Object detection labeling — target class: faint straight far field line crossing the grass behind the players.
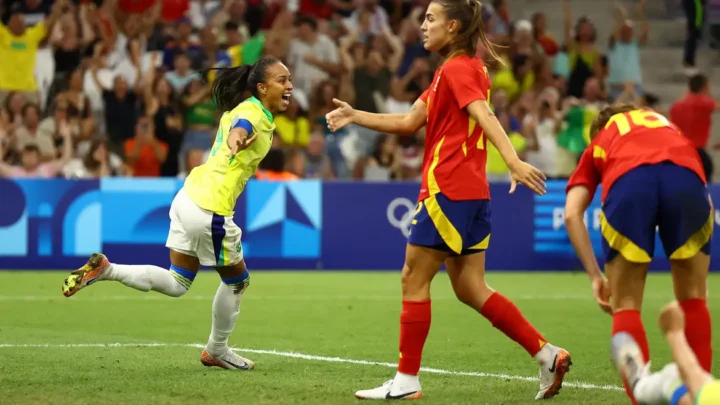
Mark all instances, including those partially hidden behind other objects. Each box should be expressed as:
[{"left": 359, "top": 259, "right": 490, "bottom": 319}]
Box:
[{"left": 0, "top": 292, "right": 688, "bottom": 302}]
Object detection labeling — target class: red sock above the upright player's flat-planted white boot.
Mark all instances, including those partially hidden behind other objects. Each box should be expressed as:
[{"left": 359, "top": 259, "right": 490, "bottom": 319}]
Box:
[{"left": 398, "top": 300, "right": 432, "bottom": 375}]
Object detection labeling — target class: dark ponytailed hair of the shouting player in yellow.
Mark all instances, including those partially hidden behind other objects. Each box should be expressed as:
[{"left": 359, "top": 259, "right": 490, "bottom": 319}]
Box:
[{"left": 201, "top": 56, "right": 280, "bottom": 111}]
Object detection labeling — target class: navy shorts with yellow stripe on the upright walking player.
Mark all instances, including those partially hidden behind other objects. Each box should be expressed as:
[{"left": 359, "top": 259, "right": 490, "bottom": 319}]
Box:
[{"left": 408, "top": 194, "right": 490, "bottom": 255}]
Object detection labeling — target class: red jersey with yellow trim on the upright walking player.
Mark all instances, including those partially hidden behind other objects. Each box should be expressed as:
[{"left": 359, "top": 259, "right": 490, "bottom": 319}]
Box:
[{"left": 418, "top": 56, "right": 490, "bottom": 201}]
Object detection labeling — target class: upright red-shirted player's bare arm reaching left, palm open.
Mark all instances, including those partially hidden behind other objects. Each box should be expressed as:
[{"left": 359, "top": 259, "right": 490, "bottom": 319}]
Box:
[{"left": 325, "top": 99, "right": 427, "bottom": 135}]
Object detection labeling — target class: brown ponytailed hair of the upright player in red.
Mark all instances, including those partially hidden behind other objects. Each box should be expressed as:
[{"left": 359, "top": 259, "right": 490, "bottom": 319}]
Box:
[{"left": 433, "top": 0, "right": 504, "bottom": 64}]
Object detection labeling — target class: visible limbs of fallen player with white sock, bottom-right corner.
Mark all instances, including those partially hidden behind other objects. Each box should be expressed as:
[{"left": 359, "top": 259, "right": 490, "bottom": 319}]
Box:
[{"left": 612, "top": 301, "right": 720, "bottom": 405}]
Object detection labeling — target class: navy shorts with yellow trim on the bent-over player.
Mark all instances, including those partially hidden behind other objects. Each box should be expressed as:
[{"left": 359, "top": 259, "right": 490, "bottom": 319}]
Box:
[{"left": 600, "top": 162, "right": 714, "bottom": 263}]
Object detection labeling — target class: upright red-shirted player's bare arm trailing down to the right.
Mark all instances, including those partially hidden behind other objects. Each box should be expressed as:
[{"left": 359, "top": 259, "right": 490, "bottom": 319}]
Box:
[{"left": 466, "top": 100, "right": 546, "bottom": 195}]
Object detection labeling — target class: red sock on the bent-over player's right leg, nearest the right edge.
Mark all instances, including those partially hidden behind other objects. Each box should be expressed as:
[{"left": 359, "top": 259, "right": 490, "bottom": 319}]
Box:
[{"left": 680, "top": 299, "right": 712, "bottom": 373}]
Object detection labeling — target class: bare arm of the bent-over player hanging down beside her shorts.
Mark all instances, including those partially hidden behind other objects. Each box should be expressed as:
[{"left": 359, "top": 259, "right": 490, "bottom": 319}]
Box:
[{"left": 565, "top": 186, "right": 612, "bottom": 314}]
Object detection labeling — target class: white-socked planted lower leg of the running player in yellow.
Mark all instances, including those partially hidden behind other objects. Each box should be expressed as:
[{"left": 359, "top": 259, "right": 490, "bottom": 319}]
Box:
[{"left": 206, "top": 269, "right": 250, "bottom": 356}]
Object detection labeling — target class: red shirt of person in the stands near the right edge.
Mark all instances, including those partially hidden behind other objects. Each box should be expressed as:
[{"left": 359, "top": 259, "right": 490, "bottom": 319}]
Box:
[{"left": 670, "top": 94, "right": 715, "bottom": 148}]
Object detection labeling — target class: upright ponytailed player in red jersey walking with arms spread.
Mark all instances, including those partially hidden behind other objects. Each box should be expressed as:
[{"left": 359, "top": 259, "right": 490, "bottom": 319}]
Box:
[{"left": 327, "top": 0, "right": 570, "bottom": 399}]
